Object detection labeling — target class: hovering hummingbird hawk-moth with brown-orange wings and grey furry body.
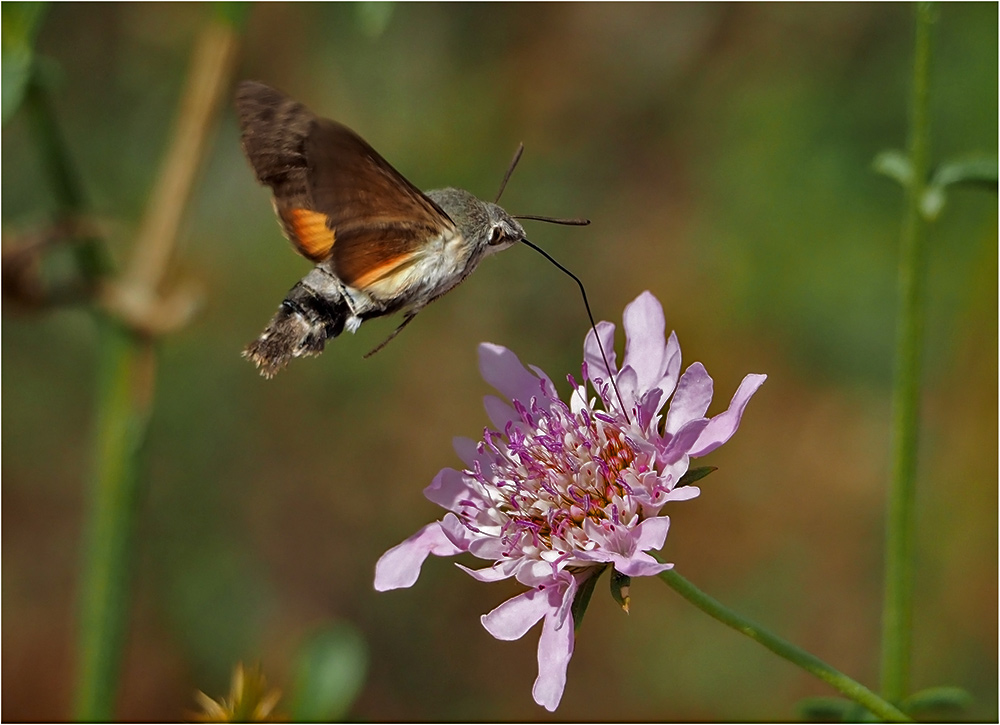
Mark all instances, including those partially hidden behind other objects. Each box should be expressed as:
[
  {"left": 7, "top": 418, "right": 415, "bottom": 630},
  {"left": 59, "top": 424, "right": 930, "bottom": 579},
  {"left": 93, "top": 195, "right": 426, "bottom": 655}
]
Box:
[{"left": 236, "top": 81, "right": 588, "bottom": 378}]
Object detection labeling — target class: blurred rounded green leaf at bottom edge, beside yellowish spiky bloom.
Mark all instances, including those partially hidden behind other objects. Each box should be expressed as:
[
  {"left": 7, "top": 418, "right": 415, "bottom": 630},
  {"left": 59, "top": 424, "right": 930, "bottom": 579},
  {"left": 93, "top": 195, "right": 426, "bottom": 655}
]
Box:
[{"left": 289, "top": 622, "right": 368, "bottom": 722}]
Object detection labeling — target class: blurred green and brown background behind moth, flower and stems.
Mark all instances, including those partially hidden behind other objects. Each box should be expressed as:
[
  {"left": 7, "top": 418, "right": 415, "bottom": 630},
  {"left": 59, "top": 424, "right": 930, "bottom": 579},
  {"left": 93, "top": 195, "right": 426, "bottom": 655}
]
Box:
[{"left": 2, "top": 3, "right": 998, "bottom": 721}]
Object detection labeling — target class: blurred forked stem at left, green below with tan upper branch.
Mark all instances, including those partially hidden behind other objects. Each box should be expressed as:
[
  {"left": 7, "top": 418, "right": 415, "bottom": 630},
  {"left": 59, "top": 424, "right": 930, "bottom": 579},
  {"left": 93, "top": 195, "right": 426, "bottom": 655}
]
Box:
[{"left": 26, "top": 19, "right": 237, "bottom": 722}]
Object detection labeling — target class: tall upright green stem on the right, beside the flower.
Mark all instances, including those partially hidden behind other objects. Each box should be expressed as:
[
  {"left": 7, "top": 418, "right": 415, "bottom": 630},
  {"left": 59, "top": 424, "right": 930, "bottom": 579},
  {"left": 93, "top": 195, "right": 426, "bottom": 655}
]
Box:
[{"left": 881, "top": 2, "right": 934, "bottom": 702}]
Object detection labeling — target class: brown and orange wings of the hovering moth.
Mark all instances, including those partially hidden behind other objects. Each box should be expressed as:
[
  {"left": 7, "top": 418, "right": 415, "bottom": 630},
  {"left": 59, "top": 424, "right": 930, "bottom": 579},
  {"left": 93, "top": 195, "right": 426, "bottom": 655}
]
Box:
[{"left": 236, "top": 81, "right": 458, "bottom": 289}]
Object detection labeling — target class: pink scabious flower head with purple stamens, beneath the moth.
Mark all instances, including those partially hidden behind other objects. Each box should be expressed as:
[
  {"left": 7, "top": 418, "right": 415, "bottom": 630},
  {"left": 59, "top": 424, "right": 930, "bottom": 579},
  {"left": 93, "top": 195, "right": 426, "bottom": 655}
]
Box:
[{"left": 375, "top": 292, "right": 766, "bottom": 711}]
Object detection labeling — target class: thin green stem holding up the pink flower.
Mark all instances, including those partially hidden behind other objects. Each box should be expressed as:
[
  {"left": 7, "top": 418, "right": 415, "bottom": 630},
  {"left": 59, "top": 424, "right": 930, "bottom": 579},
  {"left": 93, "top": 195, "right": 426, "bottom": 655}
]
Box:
[{"left": 658, "top": 569, "right": 910, "bottom": 722}]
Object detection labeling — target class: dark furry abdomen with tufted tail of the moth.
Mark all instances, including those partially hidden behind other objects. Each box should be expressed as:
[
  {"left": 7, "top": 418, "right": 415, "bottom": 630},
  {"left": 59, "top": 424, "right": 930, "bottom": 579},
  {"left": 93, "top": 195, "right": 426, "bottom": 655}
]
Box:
[{"left": 243, "top": 280, "right": 353, "bottom": 378}]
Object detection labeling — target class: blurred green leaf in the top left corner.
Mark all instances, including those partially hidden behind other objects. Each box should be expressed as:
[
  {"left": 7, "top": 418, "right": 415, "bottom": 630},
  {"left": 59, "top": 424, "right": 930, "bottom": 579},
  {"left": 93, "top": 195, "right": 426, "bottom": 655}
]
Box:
[{"left": 0, "top": 2, "right": 45, "bottom": 123}]
